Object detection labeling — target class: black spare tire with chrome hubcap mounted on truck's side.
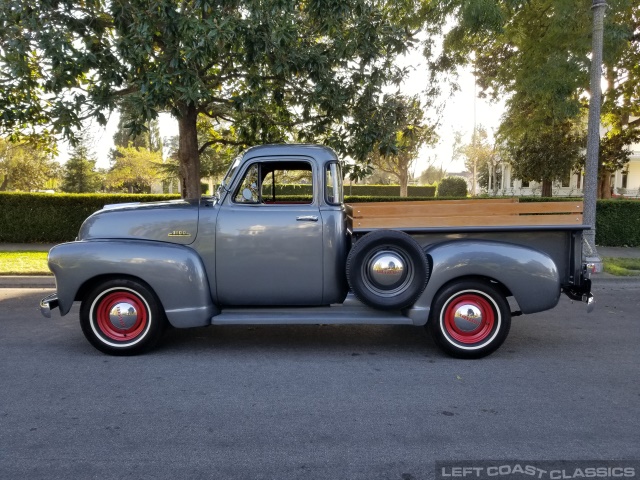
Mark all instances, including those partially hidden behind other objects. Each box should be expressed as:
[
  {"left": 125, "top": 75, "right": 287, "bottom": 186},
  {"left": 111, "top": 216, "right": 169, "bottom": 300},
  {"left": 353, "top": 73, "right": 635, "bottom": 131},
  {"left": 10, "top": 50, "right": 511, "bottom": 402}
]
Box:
[{"left": 347, "top": 230, "right": 429, "bottom": 310}]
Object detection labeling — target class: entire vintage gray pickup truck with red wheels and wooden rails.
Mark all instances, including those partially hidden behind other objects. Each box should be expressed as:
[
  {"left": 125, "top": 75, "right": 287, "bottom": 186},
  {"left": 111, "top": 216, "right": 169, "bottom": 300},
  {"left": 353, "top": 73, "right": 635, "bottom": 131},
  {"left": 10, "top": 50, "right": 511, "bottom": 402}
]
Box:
[{"left": 40, "top": 145, "right": 593, "bottom": 358}]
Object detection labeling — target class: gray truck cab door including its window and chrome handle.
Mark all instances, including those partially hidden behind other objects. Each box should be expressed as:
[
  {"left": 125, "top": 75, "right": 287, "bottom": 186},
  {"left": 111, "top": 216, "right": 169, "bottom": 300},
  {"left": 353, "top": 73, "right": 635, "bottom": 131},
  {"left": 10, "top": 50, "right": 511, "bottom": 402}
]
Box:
[{"left": 216, "top": 158, "right": 323, "bottom": 306}]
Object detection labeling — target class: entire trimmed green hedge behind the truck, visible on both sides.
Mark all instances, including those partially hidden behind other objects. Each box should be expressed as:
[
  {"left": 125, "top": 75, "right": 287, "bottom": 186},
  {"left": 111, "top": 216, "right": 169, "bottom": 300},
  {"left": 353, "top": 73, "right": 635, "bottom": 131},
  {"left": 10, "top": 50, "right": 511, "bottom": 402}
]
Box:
[{"left": 0, "top": 191, "right": 640, "bottom": 247}]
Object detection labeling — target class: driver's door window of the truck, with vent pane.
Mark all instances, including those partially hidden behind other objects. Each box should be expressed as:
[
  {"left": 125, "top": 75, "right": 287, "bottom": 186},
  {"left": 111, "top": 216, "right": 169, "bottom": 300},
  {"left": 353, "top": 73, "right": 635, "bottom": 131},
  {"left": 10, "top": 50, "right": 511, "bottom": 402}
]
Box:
[{"left": 233, "top": 161, "right": 313, "bottom": 205}]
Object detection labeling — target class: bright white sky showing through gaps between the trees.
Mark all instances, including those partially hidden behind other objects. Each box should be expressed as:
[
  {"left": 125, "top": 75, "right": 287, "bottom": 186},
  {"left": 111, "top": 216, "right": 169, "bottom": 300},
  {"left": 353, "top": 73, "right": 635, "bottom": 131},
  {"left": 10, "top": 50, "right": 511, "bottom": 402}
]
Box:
[{"left": 58, "top": 45, "right": 504, "bottom": 175}]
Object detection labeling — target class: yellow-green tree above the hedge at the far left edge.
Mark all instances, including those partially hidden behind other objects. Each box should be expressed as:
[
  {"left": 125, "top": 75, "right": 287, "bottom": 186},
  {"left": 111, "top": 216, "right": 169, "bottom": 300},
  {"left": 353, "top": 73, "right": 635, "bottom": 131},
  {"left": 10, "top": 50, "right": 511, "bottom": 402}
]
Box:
[{"left": 0, "top": 138, "right": 59, "bottom": 192}]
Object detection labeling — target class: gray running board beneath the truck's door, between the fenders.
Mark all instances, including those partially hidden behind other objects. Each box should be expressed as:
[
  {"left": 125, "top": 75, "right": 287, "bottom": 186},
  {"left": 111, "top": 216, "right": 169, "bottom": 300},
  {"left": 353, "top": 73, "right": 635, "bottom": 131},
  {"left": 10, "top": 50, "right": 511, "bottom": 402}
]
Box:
[{"left": 211, "top": 303, "right": 413, "bottom": 325}]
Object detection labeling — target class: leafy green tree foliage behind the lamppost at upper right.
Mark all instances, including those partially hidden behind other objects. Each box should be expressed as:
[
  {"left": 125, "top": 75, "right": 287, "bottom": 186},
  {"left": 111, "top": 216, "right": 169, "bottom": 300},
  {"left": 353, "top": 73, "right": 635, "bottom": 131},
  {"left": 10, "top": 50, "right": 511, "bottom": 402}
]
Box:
[{"left": 428, "top": 0, "right": 640, "bottom": 197}]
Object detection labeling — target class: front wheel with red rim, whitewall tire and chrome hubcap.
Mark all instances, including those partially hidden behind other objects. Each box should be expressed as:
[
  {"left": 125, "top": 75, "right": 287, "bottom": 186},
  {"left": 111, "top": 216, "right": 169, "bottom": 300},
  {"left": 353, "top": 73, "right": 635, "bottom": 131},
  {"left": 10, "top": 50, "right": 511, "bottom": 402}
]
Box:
[{"left": 80, "top": 280, "right": 166, "bottom": 355}]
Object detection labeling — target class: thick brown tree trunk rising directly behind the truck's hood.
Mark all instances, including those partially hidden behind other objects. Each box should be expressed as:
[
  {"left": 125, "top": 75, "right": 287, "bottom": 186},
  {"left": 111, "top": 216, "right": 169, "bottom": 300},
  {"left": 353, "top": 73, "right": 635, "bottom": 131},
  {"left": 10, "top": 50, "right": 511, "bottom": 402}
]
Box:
[{"left": 178, "top": 104, "right": 201, "bottom": 198}]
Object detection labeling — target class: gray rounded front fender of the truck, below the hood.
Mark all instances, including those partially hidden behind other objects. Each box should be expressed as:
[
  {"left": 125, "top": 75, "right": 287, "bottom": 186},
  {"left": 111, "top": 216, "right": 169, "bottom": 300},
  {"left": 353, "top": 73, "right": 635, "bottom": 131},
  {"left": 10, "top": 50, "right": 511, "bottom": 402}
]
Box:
[{"left": 49, "top": 240, "right": 219, "bottom": 328}]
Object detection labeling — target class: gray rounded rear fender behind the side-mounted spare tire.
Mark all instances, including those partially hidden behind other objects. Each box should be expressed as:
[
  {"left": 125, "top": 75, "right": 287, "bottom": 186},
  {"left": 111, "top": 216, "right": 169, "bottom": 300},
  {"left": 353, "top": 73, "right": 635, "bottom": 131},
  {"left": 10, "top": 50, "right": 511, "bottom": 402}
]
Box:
[{"left": 409, "top": 240, "right": 560, "bottom": 323}]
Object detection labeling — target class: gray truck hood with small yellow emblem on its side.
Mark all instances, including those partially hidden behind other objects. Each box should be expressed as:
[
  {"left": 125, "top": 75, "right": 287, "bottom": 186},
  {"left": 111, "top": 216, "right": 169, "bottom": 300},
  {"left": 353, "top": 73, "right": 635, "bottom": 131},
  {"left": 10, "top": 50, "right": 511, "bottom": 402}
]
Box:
[{"left": 78, "top": 200, "right": 199, "bottom": 245}]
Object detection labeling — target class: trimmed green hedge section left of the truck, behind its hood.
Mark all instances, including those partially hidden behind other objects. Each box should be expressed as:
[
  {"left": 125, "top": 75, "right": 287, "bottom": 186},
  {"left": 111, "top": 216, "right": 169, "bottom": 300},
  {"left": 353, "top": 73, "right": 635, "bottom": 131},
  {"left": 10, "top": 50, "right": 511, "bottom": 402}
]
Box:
[{"left": 0, "top": 192, "right": 180, "bottom": 243}]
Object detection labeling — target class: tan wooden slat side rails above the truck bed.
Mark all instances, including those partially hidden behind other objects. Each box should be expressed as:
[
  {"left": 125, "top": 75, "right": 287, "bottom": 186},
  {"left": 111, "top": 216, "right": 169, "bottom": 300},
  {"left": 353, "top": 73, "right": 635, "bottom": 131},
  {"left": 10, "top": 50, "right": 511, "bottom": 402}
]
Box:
[{"left": 345, "top": 198, "right": 583, "bottom": 231}]
